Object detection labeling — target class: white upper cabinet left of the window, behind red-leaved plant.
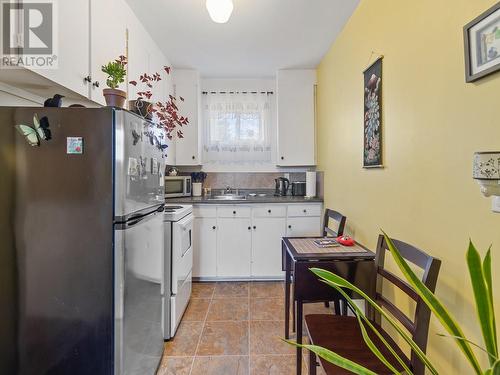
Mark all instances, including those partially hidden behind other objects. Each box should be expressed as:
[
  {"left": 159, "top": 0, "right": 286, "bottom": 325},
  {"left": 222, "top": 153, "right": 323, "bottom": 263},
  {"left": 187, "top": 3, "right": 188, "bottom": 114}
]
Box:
[{"left": 173, "top": 69, "right": 201, "bottom": 165}]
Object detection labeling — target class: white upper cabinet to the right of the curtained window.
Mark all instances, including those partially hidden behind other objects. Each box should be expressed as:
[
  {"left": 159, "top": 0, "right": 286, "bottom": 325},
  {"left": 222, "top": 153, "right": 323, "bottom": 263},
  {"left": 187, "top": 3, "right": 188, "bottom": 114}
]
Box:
[{"left": 277, "top": 70, "right": 316, "bottom": 167}]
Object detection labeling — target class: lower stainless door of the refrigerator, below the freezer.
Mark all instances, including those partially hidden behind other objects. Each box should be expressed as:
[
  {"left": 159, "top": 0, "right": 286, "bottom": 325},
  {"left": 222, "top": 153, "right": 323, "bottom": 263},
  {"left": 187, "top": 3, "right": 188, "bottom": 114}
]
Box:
[{"left": 115, "top": 211, "right": 164, "bottom": 375}]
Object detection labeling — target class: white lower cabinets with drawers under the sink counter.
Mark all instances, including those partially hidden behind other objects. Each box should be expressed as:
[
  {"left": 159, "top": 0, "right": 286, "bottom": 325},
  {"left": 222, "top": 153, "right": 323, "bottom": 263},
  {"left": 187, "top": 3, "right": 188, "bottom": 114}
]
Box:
[{"left": 193, "top": 203, "right": 322, "bottom": 279}]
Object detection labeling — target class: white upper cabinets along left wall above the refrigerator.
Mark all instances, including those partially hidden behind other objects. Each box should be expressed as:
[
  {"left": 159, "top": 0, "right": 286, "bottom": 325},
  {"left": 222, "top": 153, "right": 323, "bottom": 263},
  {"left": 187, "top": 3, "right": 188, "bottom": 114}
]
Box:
[{"left": 4, "top": 0, "right": 168, "bottom": 105}]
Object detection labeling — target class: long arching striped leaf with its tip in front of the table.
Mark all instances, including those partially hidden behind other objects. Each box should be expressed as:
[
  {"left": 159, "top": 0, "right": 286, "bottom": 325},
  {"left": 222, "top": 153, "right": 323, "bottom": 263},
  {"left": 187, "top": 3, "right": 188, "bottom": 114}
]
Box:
[{"left": 310, "top": 268, "right": 438, "bottom": 375}]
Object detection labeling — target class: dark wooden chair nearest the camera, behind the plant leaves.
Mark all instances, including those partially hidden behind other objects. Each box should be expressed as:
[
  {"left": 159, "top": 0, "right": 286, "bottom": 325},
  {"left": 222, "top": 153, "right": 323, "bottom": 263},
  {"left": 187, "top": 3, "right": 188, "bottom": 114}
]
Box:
[{"left": 305, "top": 236, "right": 441, "bottom": 375}]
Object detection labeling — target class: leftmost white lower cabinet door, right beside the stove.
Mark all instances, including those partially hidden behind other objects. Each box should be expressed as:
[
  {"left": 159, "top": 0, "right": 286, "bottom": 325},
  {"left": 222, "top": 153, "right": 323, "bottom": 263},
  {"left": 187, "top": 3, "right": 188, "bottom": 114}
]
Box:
[{"left": 193, "top": 218, "right": 217, "bottom": 277}]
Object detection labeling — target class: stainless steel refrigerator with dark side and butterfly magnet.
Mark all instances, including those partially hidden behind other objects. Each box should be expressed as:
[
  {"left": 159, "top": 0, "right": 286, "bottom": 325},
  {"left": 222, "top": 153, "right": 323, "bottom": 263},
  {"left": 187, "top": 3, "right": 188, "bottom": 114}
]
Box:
[{"left": 0, "top": 107, "right": 165, "bottom": 375}]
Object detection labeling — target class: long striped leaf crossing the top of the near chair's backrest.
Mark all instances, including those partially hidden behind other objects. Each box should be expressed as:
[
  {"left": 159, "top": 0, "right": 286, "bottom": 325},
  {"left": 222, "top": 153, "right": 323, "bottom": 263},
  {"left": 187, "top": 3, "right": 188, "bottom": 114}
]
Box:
[{"left": 383, "top": 232, "right": 483, "bottom": 375}]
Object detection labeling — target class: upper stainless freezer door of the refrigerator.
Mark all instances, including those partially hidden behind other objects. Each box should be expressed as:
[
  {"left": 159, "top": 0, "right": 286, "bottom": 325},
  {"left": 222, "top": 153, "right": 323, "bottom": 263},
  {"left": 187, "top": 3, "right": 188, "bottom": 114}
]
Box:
[{"left": 115, "top": 110, "right": 166, "bottom": 217}]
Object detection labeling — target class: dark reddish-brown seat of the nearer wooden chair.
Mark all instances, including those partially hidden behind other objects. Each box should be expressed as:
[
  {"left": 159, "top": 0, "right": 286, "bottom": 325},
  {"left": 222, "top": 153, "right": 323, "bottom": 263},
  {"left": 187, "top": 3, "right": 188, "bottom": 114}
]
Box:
[{"left": 305, "top": 314, "right": 410, "bottom": 375}]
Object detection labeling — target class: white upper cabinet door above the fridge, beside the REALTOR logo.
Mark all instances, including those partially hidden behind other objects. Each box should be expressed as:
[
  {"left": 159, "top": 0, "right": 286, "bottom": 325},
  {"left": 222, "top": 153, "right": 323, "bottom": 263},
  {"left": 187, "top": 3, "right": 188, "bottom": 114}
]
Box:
[{"left": 33, "top": 0, "right": 90, "bottom": 97}]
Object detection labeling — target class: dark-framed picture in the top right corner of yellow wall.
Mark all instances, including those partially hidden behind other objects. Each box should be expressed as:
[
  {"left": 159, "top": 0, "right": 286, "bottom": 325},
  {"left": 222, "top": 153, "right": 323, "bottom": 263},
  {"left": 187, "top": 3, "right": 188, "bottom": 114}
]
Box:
[{"left": 464, "top": 2, "right": 500, "bottom": 82}]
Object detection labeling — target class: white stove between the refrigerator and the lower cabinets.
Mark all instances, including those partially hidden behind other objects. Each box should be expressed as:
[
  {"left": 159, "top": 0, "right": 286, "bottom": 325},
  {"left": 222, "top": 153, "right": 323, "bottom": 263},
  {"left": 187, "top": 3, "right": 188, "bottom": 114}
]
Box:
[{"left": 163, "top": 204, "right": 193, "bottom": 340}]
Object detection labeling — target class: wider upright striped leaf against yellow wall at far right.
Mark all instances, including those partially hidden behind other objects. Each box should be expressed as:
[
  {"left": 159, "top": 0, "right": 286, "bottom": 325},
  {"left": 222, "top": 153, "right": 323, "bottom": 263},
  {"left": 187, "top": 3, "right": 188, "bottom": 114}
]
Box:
[{"left": 466, "top": 242, "right": 498, "bottom": 366}]
